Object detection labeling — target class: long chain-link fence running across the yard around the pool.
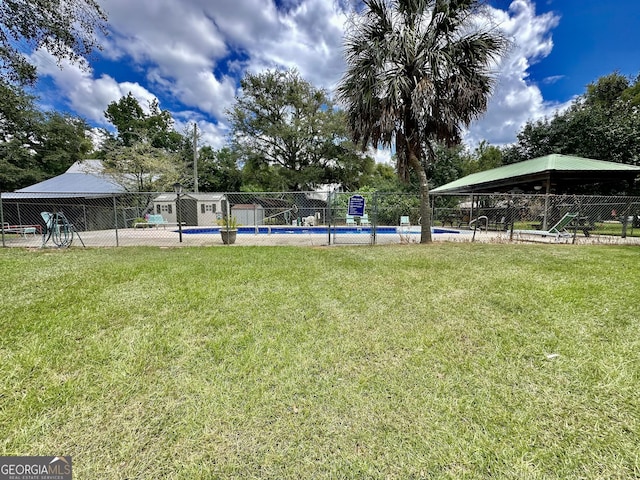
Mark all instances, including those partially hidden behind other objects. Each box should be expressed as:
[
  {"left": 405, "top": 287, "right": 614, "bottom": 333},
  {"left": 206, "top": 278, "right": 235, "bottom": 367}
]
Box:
[{"left": 0, "top": 192, "right": 640, "bottom": 247}]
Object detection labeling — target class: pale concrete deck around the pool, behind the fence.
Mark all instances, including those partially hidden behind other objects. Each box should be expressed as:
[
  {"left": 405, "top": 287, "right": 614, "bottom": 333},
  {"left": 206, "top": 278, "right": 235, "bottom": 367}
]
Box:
[{"left": 5, "top": 227, "right": 640, "bottom": 248}]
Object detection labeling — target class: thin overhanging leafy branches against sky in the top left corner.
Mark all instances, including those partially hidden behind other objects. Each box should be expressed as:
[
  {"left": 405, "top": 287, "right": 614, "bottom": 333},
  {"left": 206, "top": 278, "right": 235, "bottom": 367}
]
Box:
[{"left": 0, "top": 0, "right": 107, "bottom": 84}]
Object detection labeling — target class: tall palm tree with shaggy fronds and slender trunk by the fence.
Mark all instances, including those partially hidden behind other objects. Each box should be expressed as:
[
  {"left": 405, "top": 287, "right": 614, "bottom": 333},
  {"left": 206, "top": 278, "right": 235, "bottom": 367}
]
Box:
[{"left": 337, "top": 0, "right": 507, "bottom": 243}]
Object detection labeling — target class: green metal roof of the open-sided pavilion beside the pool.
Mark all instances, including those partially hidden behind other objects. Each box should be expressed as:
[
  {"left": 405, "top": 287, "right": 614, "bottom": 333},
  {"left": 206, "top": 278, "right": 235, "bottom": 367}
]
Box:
[{"left": 431, "top": 154, "right": 640, "bottom": 193}]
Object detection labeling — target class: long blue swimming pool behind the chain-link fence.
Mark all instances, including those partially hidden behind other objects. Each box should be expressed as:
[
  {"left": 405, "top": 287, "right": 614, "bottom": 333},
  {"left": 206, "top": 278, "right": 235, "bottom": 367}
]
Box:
[{"left": 176, "top": 225, "right": 460, "bottom": 235}]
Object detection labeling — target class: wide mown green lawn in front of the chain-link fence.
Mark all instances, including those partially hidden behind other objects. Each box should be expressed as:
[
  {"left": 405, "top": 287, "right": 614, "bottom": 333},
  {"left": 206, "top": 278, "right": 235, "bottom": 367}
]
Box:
[{"left": 0, "top": 243, "right": 640, "bottom": 479}]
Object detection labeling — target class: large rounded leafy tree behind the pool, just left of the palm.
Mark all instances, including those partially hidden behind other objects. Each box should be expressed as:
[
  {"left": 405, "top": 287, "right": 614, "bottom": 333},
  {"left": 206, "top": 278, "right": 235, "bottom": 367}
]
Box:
[{"left": 228, "top": 70, "right": 372, "bottom": 191}]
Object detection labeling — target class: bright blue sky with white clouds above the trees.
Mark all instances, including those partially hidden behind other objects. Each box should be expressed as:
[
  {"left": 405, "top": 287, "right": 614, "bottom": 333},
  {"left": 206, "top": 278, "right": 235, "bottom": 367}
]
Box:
[{"left": 27, "top": 0, "right": 640, "bottom": 161}]
